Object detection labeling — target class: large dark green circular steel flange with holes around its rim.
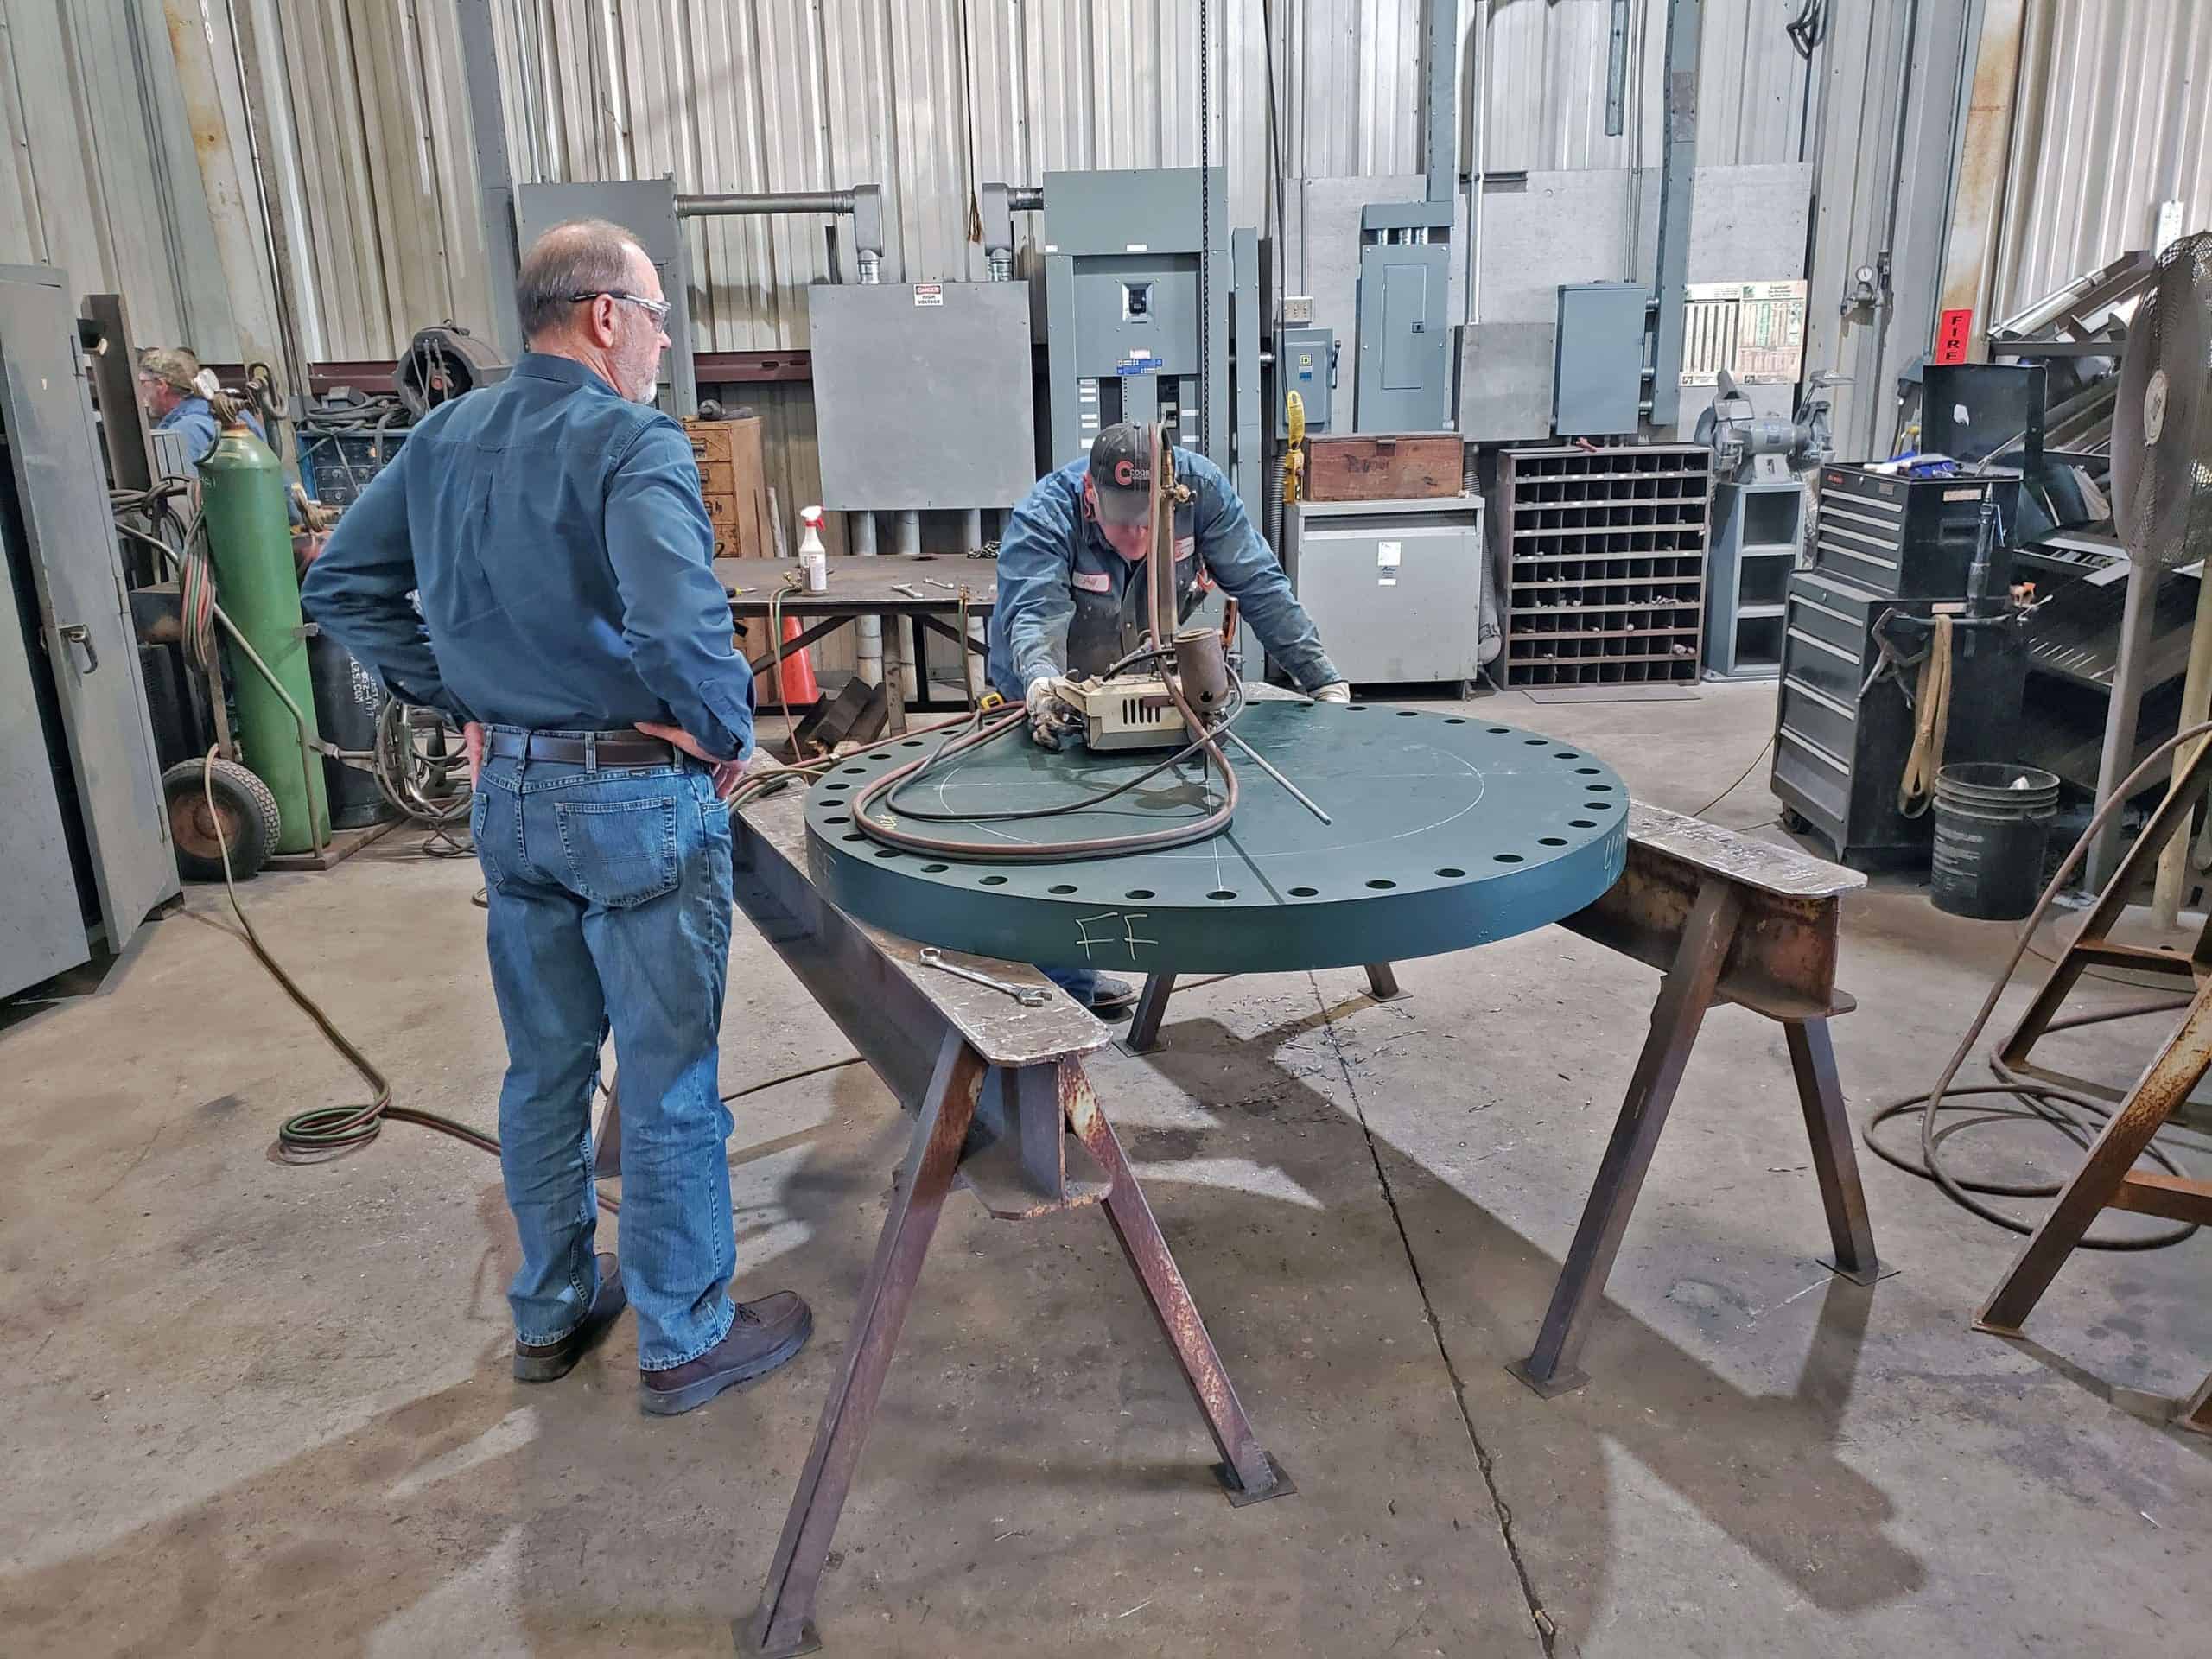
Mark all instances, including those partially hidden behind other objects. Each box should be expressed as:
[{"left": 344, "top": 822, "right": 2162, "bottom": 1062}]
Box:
[{"left": 807, "top": 702, "right": 1628, "bottom": 973}]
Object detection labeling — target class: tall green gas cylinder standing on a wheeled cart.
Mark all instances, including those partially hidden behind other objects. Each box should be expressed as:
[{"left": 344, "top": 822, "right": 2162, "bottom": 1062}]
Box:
[{"left": 199, "top": 423, "right": 329, "bottom": 852}]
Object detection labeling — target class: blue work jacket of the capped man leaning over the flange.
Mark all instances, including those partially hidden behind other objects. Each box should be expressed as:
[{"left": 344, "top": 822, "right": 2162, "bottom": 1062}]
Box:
[{"left": 991, "top": 449, "right": 1343, "bottom": 702}]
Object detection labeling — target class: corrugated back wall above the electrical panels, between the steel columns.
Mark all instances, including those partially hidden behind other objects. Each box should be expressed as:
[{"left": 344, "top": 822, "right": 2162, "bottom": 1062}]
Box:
[{"left": 462, "top": 0, "right": 1805, "bottom": 349}]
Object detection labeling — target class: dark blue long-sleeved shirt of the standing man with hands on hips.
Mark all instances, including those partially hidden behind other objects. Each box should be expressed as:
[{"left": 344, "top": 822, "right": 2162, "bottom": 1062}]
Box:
[{"left": 299, "top": 352, "right": 752, "bottom": 759}]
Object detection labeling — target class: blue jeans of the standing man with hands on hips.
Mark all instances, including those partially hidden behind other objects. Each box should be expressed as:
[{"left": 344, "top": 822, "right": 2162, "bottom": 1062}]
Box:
[{"left": 471, "top": 728, "right": 736, "bottom": 1371}]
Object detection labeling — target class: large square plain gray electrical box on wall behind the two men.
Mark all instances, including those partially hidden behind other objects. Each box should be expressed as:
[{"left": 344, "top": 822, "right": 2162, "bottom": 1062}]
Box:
[{"left": 807, "top": 283, "right": 1038, "bottom": 513}]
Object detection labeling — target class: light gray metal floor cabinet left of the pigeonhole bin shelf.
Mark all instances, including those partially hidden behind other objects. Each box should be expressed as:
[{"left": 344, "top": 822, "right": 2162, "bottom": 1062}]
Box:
[{"left": 1283, "top": 495, "right": 1486, "bottom": 686}]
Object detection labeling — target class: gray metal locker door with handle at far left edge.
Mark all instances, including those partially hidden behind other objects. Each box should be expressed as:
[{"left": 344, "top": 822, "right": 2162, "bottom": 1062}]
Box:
[{"left": 0, "top": 265, "right": 177, "bottom": 951}]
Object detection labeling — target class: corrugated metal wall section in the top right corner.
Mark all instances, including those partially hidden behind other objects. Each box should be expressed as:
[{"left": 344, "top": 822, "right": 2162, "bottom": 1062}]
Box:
[{"left": 1993, "top": 0, "right": 2212, "bottom": 316}]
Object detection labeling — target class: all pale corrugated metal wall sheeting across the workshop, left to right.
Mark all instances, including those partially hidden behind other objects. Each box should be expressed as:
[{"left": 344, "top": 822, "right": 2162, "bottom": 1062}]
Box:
[{"left": 0, "top": 0, "right": 2212, "bottom": 448}]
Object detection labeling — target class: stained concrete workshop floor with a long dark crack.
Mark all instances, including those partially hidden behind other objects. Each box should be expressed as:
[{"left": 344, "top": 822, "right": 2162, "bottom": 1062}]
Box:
[{"left": 0, "top": 686, "right": 2212, "bottom": 1659}]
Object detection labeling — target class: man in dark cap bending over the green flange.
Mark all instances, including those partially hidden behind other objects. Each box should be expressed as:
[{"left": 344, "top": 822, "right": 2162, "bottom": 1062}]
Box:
[{"left": 991, "top": 423, "right": 1351, "bottom": 1013}]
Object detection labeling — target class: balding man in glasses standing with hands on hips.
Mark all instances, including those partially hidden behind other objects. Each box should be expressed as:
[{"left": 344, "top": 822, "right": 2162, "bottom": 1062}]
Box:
[{"left": 301, "top": 221, "right": 812, "bottom": 1415}]
